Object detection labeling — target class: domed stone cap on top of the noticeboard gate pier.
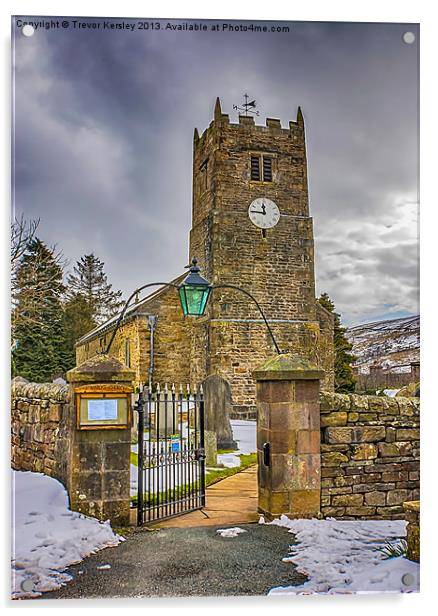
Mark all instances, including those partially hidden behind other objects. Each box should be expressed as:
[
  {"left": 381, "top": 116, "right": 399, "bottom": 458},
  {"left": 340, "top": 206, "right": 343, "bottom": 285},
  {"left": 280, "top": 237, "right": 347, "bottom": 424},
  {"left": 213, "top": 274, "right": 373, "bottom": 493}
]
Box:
[{"left": 67, "top": 354, "right": 135, "bottom": 383}]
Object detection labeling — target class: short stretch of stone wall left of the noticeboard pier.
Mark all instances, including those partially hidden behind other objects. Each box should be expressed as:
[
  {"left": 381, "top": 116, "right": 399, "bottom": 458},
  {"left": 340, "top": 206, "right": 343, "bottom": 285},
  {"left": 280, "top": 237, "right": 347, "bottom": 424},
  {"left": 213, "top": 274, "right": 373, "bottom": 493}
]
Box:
[{"left": 11, "top": 378, "right": 69, "bottom": 484}]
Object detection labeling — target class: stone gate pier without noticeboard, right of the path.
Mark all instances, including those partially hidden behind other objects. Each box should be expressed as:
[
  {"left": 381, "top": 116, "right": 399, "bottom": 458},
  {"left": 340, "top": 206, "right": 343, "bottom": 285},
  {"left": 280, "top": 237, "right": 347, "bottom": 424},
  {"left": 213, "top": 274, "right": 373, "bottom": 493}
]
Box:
[{"left": 253, "top": 354, "right": 324, "bottom": 517}]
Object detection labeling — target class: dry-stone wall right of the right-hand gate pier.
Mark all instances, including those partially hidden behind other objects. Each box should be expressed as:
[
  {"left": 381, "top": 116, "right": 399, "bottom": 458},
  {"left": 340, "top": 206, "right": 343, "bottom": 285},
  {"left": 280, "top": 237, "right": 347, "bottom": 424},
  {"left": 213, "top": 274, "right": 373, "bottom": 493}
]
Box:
[{"left": 320, "top": 392, "right": 420, "bottom": 519}]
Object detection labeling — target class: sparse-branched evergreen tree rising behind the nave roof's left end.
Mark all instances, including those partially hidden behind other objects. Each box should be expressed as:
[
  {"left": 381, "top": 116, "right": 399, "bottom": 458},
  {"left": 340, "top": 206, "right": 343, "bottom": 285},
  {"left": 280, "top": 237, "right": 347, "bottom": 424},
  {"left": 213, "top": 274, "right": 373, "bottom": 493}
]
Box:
[{"left": 67, "top": 253, "right": 123, "bottom": 324}]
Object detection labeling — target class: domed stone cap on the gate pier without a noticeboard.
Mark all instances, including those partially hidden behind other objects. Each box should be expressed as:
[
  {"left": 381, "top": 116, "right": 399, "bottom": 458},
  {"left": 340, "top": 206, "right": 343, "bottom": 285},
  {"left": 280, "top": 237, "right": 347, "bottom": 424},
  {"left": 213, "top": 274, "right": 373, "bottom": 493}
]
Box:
[{"left": 252, "top": 353, "right": 324, "bottom": 381}]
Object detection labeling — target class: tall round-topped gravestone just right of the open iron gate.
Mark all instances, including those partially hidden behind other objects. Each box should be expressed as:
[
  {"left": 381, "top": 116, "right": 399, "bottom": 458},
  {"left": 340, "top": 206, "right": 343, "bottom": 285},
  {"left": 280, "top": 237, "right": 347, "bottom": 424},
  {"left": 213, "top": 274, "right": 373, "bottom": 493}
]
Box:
[{"left": 202, "top": 375, "right": 237, "bottom": 449}]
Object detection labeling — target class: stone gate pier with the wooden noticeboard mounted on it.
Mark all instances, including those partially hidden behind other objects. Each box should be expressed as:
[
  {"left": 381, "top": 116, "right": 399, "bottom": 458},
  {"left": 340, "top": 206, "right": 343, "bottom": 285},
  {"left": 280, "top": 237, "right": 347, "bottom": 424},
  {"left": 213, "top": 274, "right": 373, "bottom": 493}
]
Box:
[{"left": 67, "top": 355, "right": 135, "bottom": 526}]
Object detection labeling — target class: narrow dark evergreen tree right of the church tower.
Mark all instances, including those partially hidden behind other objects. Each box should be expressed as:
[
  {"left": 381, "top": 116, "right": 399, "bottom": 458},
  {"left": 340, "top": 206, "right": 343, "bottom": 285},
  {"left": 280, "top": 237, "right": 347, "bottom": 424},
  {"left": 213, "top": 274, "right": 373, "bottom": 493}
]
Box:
[{"left": 318, "top": 293, "right": 356, "bottom": 393}]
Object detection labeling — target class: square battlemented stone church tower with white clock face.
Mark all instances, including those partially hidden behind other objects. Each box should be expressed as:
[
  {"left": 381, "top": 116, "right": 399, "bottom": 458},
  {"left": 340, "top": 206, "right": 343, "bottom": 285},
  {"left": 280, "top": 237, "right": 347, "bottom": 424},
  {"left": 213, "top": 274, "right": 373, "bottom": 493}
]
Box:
[{"left": 190, "top": 99, "right": 333, "bottom": 412}]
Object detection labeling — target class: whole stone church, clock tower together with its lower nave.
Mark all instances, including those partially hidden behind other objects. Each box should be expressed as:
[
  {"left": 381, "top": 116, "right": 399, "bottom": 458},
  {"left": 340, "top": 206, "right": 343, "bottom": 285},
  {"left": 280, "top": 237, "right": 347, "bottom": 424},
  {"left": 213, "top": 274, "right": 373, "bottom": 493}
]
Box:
[{"left": 76, "top": 98, "right": 334, "bottom": 418}]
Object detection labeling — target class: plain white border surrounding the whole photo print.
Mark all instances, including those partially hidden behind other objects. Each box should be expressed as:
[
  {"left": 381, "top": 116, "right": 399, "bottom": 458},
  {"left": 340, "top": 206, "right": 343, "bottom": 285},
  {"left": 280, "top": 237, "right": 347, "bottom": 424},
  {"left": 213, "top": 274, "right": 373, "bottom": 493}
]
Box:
[{"left": 0, "top": 0, "right": 438, "bottom": 616}]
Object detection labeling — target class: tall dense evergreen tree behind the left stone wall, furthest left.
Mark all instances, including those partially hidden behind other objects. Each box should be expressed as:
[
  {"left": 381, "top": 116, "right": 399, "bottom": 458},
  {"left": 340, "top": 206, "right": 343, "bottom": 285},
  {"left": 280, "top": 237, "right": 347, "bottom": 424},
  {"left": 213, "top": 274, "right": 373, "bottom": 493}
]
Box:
[{"left": 12, "top": 238, "right": 72, "bottom": 382}]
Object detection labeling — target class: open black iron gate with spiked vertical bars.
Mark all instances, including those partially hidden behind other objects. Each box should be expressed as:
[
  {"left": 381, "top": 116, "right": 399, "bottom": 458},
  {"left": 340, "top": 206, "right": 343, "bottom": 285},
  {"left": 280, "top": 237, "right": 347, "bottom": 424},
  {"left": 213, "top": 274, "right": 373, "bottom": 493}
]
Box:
[{"left": 135, "top": 385, "right": 205, "bottom": 526}]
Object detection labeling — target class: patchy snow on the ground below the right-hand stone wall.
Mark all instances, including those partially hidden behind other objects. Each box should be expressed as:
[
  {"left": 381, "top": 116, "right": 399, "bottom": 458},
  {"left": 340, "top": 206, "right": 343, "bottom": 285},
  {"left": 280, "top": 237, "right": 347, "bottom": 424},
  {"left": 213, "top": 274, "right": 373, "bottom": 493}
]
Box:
[{"left": 260, "top": 515, "right": 420, "bottom": 595}]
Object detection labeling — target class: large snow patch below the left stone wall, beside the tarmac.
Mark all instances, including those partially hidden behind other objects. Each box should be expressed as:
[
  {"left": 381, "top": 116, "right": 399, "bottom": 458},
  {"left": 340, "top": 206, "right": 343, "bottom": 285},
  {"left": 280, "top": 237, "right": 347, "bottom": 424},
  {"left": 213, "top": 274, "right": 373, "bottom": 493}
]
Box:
[{"left": 12, "top": 471, "right": 124, "bottom": 598}]
